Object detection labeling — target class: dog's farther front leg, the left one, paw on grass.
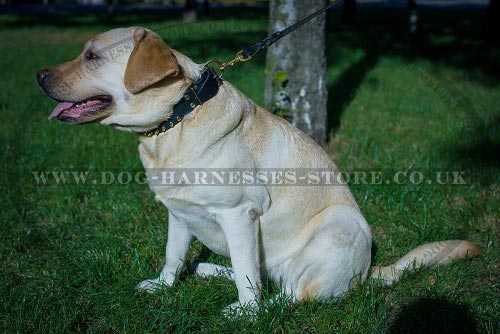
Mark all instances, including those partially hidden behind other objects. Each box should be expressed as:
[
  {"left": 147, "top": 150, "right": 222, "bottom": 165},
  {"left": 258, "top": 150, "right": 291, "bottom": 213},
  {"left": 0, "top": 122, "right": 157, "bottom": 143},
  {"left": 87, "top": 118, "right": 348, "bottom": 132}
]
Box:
[{"left": 137, "top": 212, "right": 193, "bottom": 292}]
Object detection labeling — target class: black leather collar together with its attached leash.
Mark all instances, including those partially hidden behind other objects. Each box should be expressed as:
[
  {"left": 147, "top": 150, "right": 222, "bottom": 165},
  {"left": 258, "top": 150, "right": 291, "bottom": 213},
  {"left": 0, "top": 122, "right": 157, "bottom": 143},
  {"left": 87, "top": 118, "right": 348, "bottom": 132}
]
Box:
[{"left": 139, "top": 0, "right": 338, "bottom": 137}]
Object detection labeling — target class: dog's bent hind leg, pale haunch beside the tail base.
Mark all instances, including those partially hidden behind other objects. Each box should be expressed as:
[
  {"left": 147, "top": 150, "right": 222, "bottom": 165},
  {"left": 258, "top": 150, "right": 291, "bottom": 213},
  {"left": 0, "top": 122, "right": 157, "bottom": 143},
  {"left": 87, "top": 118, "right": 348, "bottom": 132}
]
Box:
[{"left": 286, "top": 205, "right": 371, "bottom": 301}]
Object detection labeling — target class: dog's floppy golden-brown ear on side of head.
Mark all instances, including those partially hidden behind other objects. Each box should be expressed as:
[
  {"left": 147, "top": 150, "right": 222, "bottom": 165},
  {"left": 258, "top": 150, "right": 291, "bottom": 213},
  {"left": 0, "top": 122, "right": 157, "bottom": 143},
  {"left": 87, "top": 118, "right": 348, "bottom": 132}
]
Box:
[{"left": 124, "top": 28, "right": 179, "bottom": 94}]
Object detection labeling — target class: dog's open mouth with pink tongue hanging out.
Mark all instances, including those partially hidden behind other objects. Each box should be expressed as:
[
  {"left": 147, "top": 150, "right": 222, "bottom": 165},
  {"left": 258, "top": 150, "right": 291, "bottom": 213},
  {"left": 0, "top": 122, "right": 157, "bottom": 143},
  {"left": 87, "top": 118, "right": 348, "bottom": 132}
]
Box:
[{"left": 49, "top": 95, "right": 113, "bottom": 121}]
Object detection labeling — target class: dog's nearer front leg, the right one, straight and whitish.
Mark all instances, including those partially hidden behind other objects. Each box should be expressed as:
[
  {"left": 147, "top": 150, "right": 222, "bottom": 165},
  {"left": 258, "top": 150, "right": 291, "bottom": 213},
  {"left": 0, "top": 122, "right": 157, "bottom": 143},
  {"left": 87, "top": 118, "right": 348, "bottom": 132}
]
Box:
[{"left": 220, "top": 208, "right": 261, "bottom": 314}]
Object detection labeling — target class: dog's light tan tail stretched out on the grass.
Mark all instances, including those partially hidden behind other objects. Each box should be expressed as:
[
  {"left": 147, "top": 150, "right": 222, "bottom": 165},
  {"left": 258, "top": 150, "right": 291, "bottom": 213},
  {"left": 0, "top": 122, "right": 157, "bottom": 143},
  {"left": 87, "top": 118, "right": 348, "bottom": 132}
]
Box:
[{"left": 371, "top": 240, "right": 481, "bottom": 285}]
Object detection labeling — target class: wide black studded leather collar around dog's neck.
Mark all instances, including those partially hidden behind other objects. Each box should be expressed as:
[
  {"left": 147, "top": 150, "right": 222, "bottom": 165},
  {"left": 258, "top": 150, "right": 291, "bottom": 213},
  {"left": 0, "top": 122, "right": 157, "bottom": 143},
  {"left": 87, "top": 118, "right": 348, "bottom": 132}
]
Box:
[{"left": 139, "top": 67, "right": 222, "bottom": 137}]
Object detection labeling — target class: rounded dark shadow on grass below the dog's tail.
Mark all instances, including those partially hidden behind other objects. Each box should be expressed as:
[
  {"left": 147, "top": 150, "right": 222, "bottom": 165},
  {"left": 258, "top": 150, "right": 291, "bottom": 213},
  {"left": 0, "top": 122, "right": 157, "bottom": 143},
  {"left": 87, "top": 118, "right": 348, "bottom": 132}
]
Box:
[{"left": 390, "top": 298, "right": 478, "bottom": 334}]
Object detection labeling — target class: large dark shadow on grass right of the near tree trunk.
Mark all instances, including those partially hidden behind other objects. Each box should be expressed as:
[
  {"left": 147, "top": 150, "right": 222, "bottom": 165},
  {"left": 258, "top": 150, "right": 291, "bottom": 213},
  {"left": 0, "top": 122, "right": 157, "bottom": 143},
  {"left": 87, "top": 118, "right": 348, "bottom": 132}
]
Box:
[{"left": 327, "top": 9, "right": 500, "bottom": 139}]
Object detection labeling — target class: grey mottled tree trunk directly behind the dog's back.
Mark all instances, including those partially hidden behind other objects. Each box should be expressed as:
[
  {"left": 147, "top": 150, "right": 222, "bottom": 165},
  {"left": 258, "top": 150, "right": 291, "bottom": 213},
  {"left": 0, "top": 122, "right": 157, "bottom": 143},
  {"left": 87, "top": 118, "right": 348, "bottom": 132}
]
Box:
[{"left": 265, "top": 0, "right": 328, "bottom": 144}]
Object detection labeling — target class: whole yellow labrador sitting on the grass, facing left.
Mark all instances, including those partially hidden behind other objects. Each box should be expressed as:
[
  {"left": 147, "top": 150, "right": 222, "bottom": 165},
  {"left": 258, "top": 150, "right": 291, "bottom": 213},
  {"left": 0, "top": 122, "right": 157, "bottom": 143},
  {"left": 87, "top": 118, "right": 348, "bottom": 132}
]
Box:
[{"left": 37, "top": 27, "right": 479, "bottom": 309}]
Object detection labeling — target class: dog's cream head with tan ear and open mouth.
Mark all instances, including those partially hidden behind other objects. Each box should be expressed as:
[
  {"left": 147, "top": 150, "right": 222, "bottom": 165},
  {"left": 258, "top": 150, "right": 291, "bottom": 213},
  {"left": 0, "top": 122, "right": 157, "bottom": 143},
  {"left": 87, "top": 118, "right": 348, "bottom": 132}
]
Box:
[{"left": 37, "top": 27, "right": 199, "bottom": 131}]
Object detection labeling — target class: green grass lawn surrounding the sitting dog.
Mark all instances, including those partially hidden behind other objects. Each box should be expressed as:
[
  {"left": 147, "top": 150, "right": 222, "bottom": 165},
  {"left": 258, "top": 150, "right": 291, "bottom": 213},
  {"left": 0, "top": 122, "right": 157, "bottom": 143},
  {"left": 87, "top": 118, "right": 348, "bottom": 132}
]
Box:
[{"left": 0, "top": 7, "right": 500, "bottom": 333}]
